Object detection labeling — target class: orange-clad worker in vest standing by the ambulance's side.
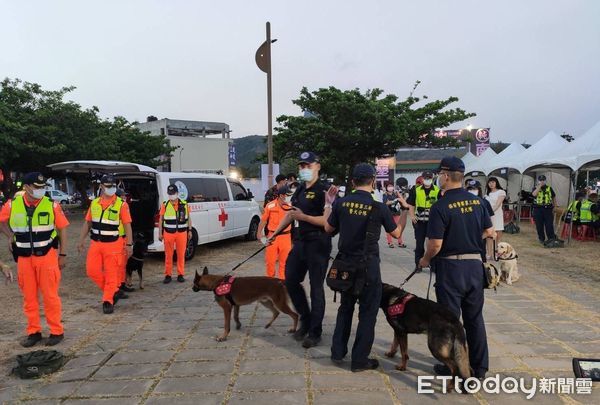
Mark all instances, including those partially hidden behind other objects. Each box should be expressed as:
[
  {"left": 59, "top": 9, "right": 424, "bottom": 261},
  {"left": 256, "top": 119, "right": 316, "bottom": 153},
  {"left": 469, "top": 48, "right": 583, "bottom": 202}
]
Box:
[{"left": 158, "top": 184, "right": 192, "bottom": 284}]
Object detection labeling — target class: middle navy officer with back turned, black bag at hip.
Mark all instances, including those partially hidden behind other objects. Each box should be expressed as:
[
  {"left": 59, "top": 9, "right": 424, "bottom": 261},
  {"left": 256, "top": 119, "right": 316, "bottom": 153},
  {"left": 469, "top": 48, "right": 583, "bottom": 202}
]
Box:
[{"left": 325, "top": 163, "right": 401, "bottom": 372}]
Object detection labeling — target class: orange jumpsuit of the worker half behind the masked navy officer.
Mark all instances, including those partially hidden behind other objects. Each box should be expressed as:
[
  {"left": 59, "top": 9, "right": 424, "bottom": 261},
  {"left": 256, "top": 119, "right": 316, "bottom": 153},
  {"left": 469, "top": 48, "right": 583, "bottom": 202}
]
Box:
[{"left": 261, "top": 200, "right": 292, "bottom": 280}]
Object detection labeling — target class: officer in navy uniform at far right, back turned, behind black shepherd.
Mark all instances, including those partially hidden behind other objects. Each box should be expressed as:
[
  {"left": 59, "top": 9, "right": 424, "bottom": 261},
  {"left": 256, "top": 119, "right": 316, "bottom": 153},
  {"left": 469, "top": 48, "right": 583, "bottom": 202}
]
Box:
[{"left": 419, "top": 157, "right": 494, "bottom": 378}]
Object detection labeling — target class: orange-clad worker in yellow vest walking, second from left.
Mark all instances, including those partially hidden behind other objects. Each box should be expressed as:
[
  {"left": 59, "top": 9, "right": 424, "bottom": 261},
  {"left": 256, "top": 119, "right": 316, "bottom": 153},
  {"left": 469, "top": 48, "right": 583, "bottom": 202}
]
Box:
[{"left": 77, "top": 174, "right": 133, "bottom": 314}]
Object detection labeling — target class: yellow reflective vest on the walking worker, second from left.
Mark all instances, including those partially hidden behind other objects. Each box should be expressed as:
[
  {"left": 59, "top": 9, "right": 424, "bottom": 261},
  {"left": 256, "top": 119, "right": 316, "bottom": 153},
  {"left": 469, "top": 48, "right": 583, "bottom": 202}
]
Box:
[{"left": 90, "top": 197, "right": 125, "bottom": 242}]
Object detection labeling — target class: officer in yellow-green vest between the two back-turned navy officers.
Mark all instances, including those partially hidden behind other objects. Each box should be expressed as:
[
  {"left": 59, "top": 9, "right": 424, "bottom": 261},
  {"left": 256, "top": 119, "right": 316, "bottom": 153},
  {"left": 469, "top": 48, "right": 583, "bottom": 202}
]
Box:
[{"left": 406, "top": 170, "right": 440, "bottom": 269}]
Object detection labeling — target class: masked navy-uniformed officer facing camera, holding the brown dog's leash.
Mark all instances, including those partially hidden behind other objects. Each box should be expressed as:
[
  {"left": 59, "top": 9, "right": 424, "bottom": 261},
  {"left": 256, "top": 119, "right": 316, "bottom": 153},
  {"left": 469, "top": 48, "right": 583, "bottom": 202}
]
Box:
[{"left": 269, "top": 152, "right": 337, "bottom": 348}]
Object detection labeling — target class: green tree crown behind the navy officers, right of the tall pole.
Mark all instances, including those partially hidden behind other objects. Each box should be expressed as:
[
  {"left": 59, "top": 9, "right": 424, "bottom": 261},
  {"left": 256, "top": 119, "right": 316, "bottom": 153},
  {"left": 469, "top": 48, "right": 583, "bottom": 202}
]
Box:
[{"left": 273, "top": 82, "right": 475, "bottom": 180}]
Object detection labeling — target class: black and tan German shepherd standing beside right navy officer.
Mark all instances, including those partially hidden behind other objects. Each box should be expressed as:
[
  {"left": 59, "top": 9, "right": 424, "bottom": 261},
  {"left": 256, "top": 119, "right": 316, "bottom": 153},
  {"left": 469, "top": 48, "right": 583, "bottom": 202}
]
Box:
[{"left": 380, "top": 283, "right": 471, "bottom": 386}]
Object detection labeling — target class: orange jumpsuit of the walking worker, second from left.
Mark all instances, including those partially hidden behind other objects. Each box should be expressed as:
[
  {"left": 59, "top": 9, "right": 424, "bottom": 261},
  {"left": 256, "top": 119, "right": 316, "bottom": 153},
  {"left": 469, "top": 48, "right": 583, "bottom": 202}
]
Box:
[{"left": 85, "top": 195, "right": 131, "bottom": 304}]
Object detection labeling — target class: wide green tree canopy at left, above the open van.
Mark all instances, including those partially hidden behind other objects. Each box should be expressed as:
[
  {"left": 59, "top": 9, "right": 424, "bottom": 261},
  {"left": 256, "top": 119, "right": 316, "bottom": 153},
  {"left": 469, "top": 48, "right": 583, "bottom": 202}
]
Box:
[{"left": 0, "top": 79, "right": 174, "bottom": 178}]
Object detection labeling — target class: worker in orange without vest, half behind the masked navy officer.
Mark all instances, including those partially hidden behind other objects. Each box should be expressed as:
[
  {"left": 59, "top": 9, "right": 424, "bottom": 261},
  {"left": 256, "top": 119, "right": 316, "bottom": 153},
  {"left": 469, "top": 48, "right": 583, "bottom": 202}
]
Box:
[{"left": 258, "top": 186, "right": 293, "bottom": 280}]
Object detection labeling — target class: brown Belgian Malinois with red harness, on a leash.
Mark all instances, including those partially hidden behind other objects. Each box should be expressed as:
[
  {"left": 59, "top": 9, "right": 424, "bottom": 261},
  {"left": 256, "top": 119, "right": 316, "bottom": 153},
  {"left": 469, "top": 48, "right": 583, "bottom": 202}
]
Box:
[{"left": 192, "top": 267, "right": 298, "bottom": 342}]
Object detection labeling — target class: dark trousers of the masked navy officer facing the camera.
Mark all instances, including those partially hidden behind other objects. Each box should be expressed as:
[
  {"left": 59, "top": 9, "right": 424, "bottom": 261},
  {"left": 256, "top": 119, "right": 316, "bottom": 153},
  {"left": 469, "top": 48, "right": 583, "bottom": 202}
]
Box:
[{"left": 285, "top": 235, "right": 331, "bottom": 337}]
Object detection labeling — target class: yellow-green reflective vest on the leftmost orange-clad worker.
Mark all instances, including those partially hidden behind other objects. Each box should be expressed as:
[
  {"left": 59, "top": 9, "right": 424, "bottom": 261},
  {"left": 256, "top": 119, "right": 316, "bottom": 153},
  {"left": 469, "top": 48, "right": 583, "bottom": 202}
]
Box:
[{"left": 9, "top": 196, "right": 57, "bottom": 257}]
